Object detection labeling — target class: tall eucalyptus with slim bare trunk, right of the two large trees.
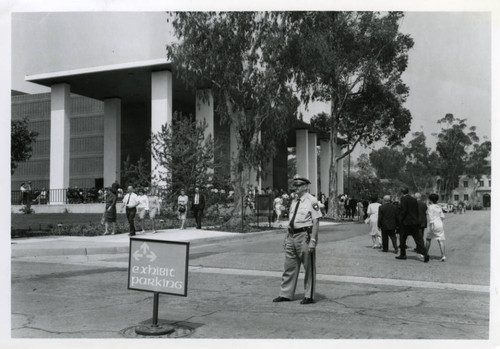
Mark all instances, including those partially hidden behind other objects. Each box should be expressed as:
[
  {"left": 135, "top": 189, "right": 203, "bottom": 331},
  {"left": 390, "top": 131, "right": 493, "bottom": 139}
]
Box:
[{"left": 280, "top": 12, "right": 413, "bottom": 217}]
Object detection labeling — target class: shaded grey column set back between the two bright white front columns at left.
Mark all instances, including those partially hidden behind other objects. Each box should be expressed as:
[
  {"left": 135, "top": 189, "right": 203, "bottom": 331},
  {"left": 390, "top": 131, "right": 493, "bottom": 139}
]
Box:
[{"left": 103, "top": 98, "right": 122, "bottom": 187}]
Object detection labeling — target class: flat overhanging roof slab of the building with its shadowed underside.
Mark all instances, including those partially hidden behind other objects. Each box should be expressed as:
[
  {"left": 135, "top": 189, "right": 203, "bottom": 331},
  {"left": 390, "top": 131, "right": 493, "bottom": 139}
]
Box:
[{"left": 25, "top": 58, "right": 195, "bottom": 104}]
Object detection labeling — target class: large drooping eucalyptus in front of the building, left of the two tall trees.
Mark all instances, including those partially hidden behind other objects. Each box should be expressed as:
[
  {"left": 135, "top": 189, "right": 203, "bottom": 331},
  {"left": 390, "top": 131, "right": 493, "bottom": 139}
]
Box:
[{"left": 167, "top": 12, "right": 299, "bottom": 226}]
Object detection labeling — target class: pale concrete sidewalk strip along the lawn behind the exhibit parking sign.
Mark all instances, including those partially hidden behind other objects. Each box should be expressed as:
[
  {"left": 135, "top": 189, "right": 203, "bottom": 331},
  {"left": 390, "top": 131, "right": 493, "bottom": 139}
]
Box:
[{"left": 11, "top": 221, "right": 338, "bottom": 258}]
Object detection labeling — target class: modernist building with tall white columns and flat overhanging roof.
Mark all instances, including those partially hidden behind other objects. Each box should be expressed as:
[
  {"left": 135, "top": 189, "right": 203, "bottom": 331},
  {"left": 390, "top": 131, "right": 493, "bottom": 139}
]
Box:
[{"left": 12, "top": 59, "right": 343, "bottom": 204}]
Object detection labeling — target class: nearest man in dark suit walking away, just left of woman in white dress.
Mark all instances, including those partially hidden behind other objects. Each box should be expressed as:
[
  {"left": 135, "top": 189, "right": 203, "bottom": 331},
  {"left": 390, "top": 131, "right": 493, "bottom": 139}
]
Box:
[{"left": 396, "top": 188, "right": 429, "bottom": 263}]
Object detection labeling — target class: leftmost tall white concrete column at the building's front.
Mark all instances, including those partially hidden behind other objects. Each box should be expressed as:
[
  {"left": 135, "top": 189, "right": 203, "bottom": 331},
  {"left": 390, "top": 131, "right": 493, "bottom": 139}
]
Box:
[{"left": 50, "top": 83, "right": 71, "bottom": 205}]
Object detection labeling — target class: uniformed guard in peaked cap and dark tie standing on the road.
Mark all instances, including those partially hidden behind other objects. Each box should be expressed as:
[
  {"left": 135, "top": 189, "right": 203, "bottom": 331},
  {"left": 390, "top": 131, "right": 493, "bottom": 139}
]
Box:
[{"left": 273, "top": 175, "right": 322, "bottom": 304}]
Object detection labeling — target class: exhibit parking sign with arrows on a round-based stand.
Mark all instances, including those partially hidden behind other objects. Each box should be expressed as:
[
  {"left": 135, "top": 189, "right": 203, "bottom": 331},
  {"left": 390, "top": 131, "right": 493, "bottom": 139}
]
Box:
[{"left": 128, "top": 238, "right": 189, "bottom": 336}]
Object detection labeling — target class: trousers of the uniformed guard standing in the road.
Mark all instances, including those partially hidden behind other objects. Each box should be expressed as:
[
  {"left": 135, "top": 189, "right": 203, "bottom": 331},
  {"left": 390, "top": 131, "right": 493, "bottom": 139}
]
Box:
[{"left": 280, "top": 232, "right": 316, "bottom": 299}]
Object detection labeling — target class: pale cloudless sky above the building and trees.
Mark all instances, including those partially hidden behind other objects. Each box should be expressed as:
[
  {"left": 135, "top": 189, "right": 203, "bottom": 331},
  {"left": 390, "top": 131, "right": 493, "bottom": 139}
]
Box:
[{"left": 12, "top": 11, "right": 492, "bottom": 158}]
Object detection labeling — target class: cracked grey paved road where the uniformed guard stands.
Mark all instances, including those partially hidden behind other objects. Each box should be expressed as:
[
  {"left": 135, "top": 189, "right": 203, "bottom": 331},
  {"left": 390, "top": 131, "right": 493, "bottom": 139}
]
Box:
[{"left": 12, "top": 211, "right": 490, "bottom": 339}]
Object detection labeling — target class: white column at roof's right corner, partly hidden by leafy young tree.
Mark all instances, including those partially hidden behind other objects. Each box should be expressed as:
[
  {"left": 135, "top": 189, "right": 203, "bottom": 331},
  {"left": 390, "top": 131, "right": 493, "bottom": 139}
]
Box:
[{"left": 151, "top": 70, "right": 173, "bottom": 186}]
